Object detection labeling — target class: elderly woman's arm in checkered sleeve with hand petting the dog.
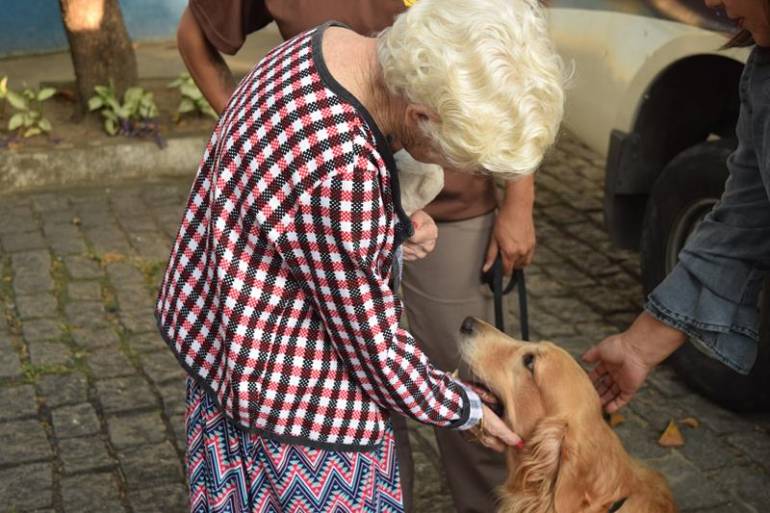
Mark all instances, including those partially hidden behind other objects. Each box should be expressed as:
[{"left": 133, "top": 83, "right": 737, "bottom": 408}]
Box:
[{"left": 276, "top": 150, "right": 519, "bottom": 445}]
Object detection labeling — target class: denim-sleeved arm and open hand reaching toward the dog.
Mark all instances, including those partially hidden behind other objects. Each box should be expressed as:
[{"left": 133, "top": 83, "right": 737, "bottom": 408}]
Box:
[{"left": 584, "top": 114, "right": 770, "bottom": 411}]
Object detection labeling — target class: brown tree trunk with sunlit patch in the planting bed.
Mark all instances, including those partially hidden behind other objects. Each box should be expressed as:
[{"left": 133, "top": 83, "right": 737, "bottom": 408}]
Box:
[{"left": 59, "top": 0, "right": 137, "bottom": 114}]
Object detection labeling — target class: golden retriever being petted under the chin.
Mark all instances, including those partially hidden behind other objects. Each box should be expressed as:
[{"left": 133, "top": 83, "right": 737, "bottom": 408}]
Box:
[{"left": 460, "top": 317, "right": 677, "bottom": 513}]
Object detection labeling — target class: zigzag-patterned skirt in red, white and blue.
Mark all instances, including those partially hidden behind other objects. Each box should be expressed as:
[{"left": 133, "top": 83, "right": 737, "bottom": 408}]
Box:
[{"left": 185, "top": 378, "right": 404, "bottom": 513}]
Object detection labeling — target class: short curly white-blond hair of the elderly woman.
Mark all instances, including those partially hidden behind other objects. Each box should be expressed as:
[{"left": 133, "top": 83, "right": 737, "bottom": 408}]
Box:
[{"left": 377, "top": 0, "right": 565, "bottom": 175}]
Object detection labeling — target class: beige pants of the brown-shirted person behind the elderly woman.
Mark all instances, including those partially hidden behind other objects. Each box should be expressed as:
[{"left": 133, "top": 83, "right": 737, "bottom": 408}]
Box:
[{"left": 393, "top": 213, "right": 506, "bottom": 513}]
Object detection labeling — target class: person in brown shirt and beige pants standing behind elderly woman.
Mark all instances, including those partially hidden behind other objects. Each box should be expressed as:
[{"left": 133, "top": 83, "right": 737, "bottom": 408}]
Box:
[{"left": 177, "top": 0, "right": 535, "bottom": 513}]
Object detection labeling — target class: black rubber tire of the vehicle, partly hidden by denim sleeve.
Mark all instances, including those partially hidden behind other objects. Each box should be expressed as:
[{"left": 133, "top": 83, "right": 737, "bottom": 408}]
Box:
[{"left": 641, "top": 140, "right": 770, "bottom": 412}]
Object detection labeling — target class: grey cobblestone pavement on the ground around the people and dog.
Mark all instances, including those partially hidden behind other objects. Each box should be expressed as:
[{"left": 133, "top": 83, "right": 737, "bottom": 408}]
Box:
[{"left": 0, "top": 135, "right": 770, "bottom": 513}]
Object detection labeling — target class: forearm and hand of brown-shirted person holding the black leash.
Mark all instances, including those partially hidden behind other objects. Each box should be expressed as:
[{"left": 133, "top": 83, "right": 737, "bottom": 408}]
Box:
[{"left": 482, "top": 175, "right": 535, "bottom": 274}]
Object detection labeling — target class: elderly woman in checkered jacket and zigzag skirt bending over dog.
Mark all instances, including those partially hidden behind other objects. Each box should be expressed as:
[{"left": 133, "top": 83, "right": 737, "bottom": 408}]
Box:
[{"left": 157, "top": 0, "right": 563, "bottom": 512}]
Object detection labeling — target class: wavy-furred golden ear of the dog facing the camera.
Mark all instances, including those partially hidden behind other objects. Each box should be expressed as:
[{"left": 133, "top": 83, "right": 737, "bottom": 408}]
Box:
[{"left": 514, "top": 417, "right": 586, "bottom": 513}]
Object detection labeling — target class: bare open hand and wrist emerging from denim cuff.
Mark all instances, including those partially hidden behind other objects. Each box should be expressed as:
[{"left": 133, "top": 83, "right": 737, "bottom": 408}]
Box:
[{"left": 583, "top": 312, "right": 687, "bottom": 413}]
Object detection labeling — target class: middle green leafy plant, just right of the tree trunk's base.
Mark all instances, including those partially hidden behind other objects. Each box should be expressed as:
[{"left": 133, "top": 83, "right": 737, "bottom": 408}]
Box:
[{"left": 88, "top": 82, "right": 164, "bottom": 147}]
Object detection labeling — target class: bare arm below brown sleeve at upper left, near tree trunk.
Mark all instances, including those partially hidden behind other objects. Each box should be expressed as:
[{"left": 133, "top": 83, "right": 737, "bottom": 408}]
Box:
[{"left": 176, "top": 7, "right": 235, "bottom": 115}]
